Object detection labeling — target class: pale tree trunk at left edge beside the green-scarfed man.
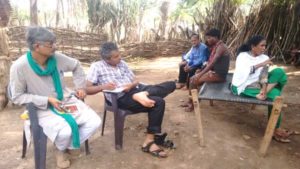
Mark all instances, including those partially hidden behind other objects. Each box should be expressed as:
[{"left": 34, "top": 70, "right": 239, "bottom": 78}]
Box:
[{"left": 0, "top": 28, "right": 11, "bottom": 111}]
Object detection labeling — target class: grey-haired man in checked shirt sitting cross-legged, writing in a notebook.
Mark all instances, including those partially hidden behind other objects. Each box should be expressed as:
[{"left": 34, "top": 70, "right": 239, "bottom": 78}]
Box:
[{"left": 87, "top": 42, "right": 176, "bottom": 157}]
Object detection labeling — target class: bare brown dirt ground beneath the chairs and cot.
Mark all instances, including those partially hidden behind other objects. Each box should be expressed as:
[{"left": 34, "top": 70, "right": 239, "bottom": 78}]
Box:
[{"left": 0, "top": 57, "right": 300, "bottom": 169}]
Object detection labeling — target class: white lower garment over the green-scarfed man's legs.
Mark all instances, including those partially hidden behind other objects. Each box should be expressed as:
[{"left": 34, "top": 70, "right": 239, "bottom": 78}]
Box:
[{"left": 24, "top": 97, "right": 101, "bottom": 150}]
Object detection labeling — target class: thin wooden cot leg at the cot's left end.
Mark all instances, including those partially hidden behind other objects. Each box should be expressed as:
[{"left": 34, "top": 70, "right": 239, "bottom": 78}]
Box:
[{"left": 192, "top": 89, "right": 204, "bottom": 147}]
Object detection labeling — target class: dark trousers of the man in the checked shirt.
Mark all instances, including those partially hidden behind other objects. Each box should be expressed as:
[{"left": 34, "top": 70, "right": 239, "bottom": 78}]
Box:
[{"left": 118, "top": 81, "right": 176, "bottom": 134}]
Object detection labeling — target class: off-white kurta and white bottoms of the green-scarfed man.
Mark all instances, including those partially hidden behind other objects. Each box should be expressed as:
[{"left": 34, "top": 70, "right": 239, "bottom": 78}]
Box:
[{"left": 9, "top": 53, "right": 101, "bottom": 150}]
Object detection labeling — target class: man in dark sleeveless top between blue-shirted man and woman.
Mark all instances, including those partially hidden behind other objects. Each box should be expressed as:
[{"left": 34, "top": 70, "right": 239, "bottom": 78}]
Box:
[{"left": 186, "top": 28, "right": 230, "bottom": 111}]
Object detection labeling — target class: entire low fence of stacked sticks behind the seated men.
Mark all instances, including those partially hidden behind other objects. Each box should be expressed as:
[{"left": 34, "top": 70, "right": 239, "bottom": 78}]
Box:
[{"left": 8, "top": 27, "right": 191, "bottom": 62}]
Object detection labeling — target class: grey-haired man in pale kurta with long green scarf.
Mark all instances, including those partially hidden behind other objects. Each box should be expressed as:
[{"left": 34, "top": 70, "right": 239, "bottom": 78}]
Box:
[{"left": 9, "top": 27, "right": 101, "bottom": 168}]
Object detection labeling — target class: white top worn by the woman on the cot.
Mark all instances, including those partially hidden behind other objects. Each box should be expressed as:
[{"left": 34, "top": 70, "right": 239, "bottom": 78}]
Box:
[{"left": 232, "top": 52, "right": 269, "bottom": 94}]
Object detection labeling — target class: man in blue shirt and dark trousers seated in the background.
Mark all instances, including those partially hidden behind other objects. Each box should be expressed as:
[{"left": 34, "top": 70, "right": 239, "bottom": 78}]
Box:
[{"left": 176, "top": 34, "right": 209, "bottom": 89}]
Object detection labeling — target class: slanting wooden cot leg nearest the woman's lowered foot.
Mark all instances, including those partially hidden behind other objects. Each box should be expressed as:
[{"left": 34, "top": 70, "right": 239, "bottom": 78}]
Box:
[{"left": 259, "top": 96, "right": 283, "bottom": 156}]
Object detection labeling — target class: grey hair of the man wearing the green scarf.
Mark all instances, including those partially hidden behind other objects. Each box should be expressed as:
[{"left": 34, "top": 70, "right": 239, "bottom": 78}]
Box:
[{"left": 26, "top": 26, "right": 56, "bottom": 50}]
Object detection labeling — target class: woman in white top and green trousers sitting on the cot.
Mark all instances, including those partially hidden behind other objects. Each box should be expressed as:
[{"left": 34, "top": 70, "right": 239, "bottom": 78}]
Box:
[{"left": 231, "top": 36, "right": 294, "bottom": 142}]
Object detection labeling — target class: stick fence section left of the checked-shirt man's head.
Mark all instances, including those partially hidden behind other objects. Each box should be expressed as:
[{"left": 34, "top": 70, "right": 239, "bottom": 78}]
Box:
[{"left": 8, "top": 26, "right": 108, "bottom": 61}]
